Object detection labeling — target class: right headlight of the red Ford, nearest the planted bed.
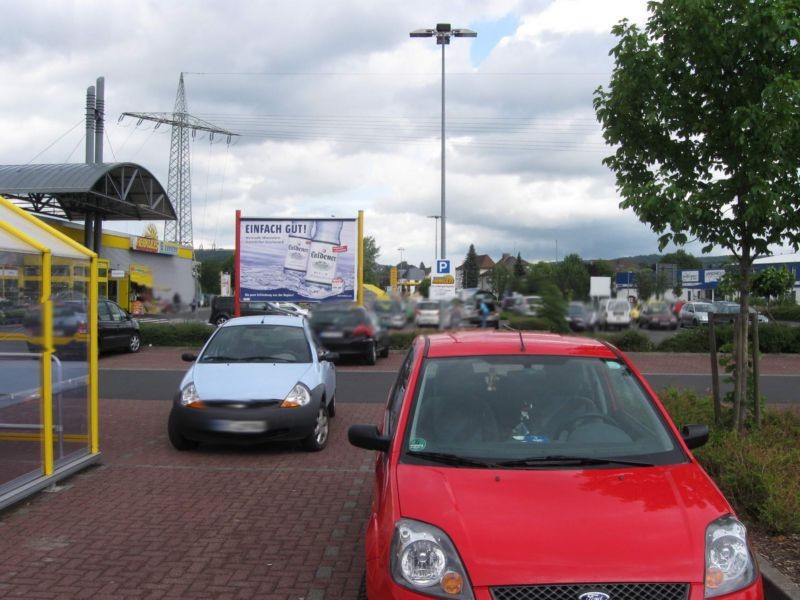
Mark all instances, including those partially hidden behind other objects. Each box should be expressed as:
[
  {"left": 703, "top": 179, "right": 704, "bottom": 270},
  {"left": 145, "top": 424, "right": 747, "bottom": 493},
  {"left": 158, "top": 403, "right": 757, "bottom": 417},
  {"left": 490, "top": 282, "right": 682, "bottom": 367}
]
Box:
[{"left": 705, "top": 515, "right": 756, "bottom": 598}]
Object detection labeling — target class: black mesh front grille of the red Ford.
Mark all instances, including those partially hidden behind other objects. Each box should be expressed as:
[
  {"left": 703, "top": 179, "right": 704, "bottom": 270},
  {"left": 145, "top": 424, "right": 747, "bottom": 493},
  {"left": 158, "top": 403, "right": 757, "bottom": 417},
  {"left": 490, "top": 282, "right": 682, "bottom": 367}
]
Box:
[{"left": 490, "top": 583, "right": 689, "bottom": 600}]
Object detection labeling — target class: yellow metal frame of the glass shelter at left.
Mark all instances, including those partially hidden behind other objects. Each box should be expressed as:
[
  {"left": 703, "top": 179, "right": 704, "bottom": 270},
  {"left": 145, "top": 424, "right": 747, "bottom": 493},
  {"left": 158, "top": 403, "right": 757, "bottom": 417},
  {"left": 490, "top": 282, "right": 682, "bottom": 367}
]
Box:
[{"left": 0, "top": 196, "right": 100, "bottom": 476}]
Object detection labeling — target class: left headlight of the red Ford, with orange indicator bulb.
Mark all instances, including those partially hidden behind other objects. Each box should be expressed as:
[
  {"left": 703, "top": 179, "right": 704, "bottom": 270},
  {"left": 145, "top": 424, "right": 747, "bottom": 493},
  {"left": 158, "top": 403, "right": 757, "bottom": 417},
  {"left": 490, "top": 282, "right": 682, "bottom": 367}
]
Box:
[{"left": 391, "top": 519, "right": 474, "bottom": 600}]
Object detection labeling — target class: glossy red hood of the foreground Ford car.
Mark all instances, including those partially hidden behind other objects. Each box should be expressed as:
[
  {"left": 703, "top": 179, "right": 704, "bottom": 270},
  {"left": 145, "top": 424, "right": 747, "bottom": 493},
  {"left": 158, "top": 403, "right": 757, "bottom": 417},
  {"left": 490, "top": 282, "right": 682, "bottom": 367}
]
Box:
[{"left": 397, "top": 464, "right": 730, "bottom": 586}]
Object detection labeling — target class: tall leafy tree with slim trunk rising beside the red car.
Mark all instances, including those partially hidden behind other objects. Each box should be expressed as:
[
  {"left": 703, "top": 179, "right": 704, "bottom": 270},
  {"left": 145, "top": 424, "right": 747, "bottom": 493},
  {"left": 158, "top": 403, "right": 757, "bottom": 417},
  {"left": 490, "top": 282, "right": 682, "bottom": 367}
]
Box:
[{"left": 594, "top": 0, "right": 800, "bottom": 430}]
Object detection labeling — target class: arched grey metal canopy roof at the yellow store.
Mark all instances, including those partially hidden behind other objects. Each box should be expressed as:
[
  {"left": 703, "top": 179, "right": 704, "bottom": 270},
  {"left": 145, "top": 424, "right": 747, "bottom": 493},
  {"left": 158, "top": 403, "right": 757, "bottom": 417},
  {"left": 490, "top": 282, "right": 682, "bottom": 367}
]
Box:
[{"left": 0, "top": 163, "right": 176, "bottom": 221}]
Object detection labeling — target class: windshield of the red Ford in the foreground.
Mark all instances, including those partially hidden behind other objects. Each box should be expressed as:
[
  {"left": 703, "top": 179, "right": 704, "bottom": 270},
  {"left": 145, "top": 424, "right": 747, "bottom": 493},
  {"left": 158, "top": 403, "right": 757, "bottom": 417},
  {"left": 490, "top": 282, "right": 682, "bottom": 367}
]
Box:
[{"left": 404, "top": 356, "right": 686, "bottom": 464}]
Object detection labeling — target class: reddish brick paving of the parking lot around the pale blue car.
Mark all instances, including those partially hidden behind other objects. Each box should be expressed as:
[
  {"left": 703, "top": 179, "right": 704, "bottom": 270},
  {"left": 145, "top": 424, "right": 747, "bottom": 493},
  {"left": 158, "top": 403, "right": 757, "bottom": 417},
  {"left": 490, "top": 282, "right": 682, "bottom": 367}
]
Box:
[{"left": 0, "top": 348, "right": 800, "bottom": 600}]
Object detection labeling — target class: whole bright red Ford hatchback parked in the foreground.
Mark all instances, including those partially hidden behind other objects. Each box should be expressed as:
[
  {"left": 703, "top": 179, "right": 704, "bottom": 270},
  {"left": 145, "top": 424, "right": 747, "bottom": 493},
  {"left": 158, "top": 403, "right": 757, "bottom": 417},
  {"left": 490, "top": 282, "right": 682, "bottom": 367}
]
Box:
[{"left": 348, "top": 332, "right": 763, "bottom": 600}]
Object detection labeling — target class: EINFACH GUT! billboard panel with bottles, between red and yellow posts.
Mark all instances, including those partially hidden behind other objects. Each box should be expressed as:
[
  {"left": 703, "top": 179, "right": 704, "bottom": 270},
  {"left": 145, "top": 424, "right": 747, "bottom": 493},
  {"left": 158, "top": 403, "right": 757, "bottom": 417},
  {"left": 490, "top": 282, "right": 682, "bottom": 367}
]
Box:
[{"left": 238, "top": 217, "right": 358, "bottom": 302}]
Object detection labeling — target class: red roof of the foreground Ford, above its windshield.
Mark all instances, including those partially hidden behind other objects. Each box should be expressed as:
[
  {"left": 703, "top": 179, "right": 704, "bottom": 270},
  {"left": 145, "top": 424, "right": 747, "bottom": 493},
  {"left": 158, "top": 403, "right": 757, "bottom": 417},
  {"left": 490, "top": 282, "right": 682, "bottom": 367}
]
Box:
[{"left": 428, "top": 331, "right": 617, "bottom": 358}]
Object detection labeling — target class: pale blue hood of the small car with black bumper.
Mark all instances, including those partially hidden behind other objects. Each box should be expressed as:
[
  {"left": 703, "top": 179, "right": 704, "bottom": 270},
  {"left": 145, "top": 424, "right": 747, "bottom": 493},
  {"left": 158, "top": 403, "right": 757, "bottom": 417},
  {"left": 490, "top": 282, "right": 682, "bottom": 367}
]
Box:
[{"left": 181, "top": 363, "right": 314, "bottom": 400}]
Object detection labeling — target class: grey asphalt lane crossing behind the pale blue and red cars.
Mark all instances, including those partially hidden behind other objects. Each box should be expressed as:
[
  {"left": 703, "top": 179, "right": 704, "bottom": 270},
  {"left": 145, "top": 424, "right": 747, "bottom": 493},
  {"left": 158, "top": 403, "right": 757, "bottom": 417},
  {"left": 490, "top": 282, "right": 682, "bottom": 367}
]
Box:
[{"left": 100, "top": 369, "right": 800, "bottom": 404}]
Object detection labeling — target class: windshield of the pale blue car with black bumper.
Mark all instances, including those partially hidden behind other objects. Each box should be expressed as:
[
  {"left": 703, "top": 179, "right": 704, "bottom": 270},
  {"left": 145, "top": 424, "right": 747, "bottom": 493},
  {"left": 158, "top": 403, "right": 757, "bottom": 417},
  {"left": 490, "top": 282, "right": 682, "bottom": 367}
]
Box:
[{"left": 198, "top": 324, "right": 311, "bottom": 363}]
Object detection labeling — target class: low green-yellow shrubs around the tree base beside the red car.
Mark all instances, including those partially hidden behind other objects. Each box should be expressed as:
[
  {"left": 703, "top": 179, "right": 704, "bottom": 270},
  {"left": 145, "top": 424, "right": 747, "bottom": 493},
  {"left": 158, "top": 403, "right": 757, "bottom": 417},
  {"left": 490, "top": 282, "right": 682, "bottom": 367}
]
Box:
[{"left": 661, "top": 389, "right": 800, "bottom": 535}]
